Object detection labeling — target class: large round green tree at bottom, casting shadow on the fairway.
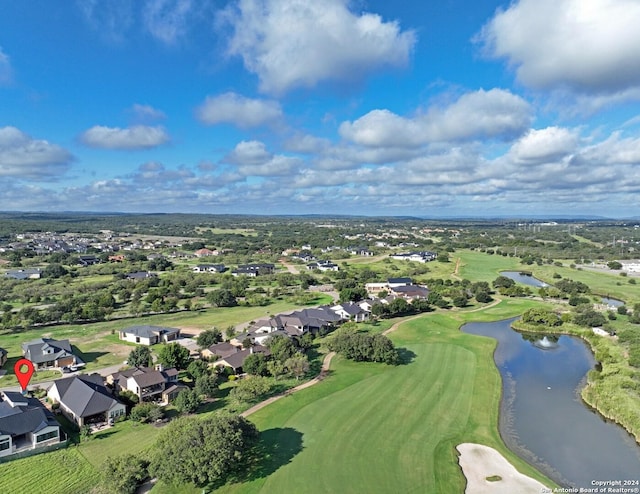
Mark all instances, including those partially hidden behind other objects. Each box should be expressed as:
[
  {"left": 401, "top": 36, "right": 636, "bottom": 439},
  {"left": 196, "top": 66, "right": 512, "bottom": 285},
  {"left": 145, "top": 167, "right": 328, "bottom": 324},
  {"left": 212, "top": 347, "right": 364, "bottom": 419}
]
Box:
[{"left": 149, "top": 415, "right": 258, "bottom": 486}]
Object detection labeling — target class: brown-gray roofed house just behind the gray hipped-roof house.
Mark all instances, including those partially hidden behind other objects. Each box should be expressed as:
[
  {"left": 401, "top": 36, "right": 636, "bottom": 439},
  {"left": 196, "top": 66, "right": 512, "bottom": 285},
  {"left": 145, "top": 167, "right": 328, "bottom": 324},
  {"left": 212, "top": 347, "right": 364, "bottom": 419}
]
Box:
[{"left": 107, "top": 365, "right": 178, "bottom": 402}]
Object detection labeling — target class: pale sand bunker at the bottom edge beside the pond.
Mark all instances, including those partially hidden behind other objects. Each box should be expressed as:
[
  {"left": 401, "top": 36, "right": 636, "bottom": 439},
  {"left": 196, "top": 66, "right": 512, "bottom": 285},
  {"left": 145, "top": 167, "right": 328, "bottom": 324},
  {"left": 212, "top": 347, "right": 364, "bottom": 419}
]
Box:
[{"left": 457, "top": 443, "right": 550, "bottom": 494}]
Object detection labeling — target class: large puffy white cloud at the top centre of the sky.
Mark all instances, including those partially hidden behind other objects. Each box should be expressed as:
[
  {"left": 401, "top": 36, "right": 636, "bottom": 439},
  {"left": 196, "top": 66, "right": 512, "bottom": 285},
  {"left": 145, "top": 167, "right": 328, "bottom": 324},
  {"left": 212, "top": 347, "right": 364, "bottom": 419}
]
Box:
[{"left": 220, "top": 0, "right": 416, "bottom": 94}]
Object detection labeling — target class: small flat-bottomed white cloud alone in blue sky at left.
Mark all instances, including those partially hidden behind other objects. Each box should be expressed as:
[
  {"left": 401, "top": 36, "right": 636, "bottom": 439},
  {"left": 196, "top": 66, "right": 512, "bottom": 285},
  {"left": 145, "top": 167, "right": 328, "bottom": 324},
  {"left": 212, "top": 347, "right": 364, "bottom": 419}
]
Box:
[{"left": 80, "top": 125, "right": 169, "bottom": 150}]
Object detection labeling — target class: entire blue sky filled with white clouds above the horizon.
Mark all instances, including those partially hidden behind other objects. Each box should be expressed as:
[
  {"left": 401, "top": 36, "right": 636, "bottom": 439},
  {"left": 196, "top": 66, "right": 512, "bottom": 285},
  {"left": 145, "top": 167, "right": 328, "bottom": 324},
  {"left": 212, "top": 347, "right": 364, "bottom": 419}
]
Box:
[{"left": 0, "top": 0, "right": 640, "bottom": 217}]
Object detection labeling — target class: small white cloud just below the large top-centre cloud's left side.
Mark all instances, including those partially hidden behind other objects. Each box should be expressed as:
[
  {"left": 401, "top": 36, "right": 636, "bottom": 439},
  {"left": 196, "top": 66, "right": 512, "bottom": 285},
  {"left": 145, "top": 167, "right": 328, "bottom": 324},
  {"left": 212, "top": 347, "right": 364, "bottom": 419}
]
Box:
[{"left": 196, "top": 92, "right": 282, "bottom": 128}]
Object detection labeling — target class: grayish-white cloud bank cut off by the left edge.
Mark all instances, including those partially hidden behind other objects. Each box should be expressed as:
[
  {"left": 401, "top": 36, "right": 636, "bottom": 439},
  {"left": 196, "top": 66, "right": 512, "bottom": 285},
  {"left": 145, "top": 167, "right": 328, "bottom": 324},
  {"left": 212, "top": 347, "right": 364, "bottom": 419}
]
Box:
[{"left": 0, "top": 127, "right": 73, "bottom": 180}]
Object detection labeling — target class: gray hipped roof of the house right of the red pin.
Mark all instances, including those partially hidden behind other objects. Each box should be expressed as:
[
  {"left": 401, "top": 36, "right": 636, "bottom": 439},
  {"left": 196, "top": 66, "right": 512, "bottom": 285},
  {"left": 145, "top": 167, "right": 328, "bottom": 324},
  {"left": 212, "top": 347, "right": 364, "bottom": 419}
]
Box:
[{"left": 53, "top": 374, "right": 120, "bottom": 417}]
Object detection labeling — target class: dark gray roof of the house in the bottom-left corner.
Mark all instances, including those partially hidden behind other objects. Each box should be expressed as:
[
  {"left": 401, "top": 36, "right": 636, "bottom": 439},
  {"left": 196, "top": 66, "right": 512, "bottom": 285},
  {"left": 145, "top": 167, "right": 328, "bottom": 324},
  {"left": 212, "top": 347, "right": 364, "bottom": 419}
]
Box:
[{"left": 0, "top": 392, "right": 58, "bottom": 436}]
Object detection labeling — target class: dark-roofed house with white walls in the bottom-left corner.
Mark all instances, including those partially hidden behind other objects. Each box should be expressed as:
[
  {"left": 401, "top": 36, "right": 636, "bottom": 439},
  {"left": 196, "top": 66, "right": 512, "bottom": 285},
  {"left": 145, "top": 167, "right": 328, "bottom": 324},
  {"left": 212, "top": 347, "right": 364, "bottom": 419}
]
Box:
[{"left": 0, "top": 391, "right": 62, "bottom": 458}]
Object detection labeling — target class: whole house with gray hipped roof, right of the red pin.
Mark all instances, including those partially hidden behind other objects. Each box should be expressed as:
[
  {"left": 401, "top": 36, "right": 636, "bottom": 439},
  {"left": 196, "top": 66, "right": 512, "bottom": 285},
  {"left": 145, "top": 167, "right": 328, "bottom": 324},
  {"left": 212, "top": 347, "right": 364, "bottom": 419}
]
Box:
[{"left": 47, "top": 374, "right": 126, "bottom": 427}]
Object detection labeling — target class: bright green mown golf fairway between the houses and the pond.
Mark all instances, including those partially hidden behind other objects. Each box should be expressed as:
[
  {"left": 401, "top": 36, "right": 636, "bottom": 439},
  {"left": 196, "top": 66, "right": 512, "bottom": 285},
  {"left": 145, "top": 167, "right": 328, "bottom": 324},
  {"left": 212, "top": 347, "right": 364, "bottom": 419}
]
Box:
[{"left": 152, "top": 300, "right": 553, "bottom": 494}]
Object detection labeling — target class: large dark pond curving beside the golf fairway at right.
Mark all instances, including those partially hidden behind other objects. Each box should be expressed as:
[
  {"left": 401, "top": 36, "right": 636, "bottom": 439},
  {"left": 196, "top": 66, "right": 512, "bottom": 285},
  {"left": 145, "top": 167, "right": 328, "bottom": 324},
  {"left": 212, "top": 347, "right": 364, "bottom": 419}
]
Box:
[{"left": 462, "top": 319, "right": 640, "bottom": 488}]
